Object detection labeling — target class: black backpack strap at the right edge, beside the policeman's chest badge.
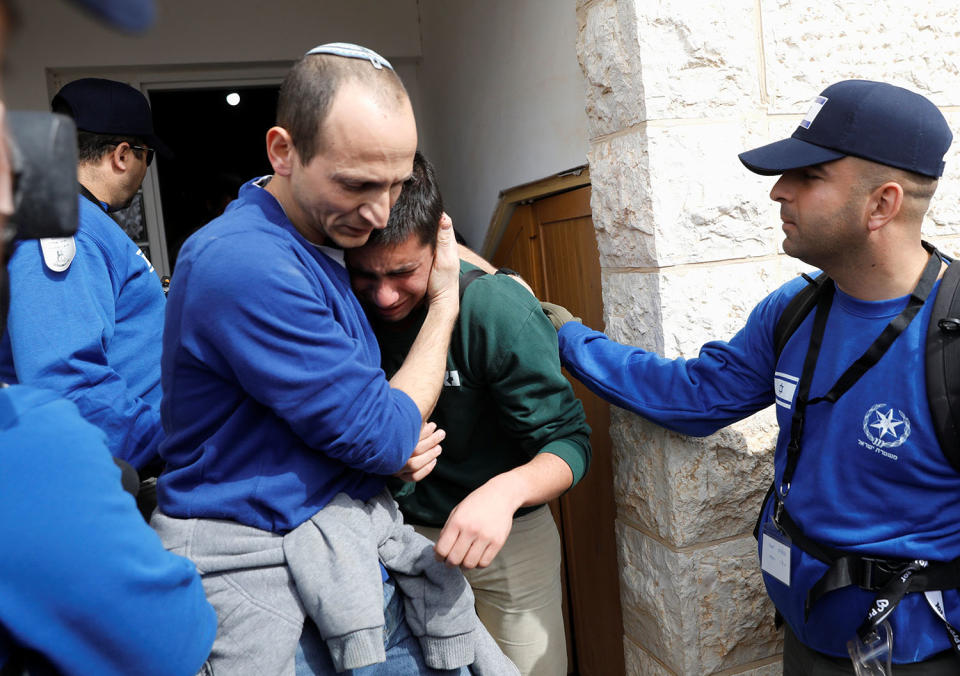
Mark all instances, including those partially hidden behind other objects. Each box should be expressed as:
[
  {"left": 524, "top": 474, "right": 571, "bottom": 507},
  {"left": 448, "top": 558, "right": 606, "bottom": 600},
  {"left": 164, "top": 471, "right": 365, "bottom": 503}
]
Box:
[{"left": 924, "top": 262, "right": 960, "bottom": 471}]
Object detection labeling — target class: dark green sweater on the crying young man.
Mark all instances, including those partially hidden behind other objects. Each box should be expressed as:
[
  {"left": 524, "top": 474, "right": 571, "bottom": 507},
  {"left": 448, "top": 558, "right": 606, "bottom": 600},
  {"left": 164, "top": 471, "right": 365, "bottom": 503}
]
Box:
[{"left": 373, "top": 261, "right": 590, "bottom": 527}]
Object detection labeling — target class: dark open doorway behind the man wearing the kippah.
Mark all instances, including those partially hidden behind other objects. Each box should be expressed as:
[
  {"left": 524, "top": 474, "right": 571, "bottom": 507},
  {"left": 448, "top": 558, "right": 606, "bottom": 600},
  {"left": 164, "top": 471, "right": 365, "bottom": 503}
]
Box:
[{"left": 150, "top": 86, "right": 280, "bottom": 272}]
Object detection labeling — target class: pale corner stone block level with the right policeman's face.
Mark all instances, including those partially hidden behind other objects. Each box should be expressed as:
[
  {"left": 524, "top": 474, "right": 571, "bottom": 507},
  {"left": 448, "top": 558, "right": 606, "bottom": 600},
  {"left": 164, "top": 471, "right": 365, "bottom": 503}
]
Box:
[{"left": 589, "top": 118, "right": 796, "bottom": 268}]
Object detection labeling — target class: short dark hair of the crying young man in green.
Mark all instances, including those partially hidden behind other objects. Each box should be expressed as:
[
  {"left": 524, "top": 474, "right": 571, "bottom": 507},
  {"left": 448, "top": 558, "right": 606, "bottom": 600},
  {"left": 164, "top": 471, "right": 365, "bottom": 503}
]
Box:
[{"left": 367, "top": 150, "right": 443, "bottom": 248}]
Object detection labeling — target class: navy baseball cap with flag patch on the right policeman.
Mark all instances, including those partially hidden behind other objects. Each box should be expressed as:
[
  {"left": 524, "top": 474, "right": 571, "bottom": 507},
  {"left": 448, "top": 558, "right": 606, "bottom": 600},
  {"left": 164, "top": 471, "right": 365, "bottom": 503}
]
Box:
[{"left": 738, "top": 80, "right": 953, "bottom": 178}]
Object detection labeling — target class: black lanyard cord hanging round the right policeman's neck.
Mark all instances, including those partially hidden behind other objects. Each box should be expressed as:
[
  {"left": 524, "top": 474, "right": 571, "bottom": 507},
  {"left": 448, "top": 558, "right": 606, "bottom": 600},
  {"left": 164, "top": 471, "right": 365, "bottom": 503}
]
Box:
[{"left": 774, "top": 243, "right": 941, "bottom": 510}]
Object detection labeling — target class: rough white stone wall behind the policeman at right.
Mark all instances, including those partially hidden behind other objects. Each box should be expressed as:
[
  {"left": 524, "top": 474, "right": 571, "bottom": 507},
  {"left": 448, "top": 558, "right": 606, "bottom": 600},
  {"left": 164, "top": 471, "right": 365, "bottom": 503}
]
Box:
[{"left": 577, "top": 0, "right": 960, "bottom": 676}]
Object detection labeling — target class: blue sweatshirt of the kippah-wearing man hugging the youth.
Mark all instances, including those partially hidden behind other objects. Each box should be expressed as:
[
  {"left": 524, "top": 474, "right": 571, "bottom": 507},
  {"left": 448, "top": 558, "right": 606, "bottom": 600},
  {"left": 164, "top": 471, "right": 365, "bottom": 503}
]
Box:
[{"left": 158, "top": 181, "right": 420, "bottom": 533}]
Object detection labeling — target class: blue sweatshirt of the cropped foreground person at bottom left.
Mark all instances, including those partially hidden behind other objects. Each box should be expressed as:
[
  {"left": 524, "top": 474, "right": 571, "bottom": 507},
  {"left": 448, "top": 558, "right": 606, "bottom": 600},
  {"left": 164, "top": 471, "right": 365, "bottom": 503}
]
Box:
[{"left": 0, "top": 385, "right": 217, "bottom": 676}]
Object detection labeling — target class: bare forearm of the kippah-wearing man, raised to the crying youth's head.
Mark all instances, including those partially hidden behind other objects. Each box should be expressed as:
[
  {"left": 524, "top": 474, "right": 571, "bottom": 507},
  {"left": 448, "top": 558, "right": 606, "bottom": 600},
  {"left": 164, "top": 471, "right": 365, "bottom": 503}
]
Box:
[{"left": 390, "top": 299, "right": 459, "bottom": 421}]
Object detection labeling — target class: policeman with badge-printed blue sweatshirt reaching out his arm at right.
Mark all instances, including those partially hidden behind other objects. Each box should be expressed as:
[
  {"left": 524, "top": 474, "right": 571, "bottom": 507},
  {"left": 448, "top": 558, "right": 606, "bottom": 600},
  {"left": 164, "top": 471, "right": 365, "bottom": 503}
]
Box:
[{"left": 547, "top": 80, "right": 960, "bottom": 676}]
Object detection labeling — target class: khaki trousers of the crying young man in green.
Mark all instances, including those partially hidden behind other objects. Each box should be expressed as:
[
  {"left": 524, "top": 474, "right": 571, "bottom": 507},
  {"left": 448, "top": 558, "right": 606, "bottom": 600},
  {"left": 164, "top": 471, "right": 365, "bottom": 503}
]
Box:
[{"left": 414, "top": 506, "right": 567, "bottom": 676}]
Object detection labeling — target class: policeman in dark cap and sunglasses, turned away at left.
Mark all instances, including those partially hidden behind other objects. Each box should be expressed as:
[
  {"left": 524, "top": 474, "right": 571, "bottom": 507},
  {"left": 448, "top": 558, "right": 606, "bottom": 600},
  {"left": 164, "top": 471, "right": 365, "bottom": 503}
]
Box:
[{"left": 0, "top": 78, "right": 165, "bottom": 474}]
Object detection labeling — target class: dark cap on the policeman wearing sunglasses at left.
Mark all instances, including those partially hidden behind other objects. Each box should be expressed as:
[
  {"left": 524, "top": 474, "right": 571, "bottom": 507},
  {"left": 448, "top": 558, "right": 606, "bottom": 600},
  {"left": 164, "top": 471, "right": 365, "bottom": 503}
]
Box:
[{"left": 51, "top": 77, "right": 172, "bottom": 157}]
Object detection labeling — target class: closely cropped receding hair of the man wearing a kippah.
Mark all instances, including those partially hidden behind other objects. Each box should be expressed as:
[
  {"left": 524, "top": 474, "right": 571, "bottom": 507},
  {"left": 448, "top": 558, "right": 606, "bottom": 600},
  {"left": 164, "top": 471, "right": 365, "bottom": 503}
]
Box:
[{"left": 277, "top": 54, "right": 409, "bottom": 164}]
